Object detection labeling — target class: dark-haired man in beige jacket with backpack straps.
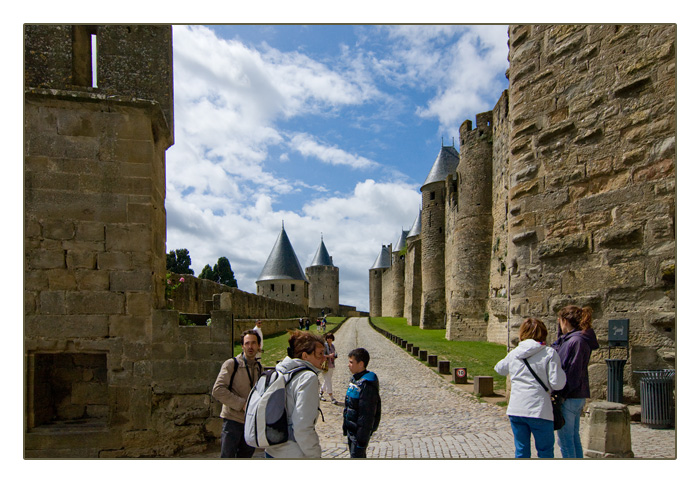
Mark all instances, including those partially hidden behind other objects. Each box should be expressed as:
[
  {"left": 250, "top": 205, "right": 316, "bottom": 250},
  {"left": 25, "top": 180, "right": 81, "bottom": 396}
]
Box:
[{"left": 211, "top": 329, "right": 262, "bottom": 458}]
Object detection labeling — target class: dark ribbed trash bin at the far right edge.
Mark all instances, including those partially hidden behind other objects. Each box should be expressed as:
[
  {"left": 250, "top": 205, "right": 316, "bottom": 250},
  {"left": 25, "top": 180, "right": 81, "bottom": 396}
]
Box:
[{"left": 635, "top": 369, "right": 676, "bottom": 429}]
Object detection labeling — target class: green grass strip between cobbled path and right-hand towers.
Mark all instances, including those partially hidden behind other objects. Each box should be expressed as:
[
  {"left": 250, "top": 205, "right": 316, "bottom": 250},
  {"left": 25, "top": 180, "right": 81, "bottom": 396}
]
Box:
[{"left": 372, "top": 317, "right": 506, "bottom": 389}]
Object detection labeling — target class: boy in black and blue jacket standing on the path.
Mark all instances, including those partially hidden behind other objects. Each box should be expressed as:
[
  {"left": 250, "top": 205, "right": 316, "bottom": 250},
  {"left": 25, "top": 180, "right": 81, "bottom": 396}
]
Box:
[{"left": 343, "top": 348, "right": 382, "bottom": 458}]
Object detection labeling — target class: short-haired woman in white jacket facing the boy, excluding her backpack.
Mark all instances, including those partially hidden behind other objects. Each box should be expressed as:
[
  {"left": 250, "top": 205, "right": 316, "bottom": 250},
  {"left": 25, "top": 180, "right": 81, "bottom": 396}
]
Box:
[{"left": 265, "top": 331, "right": 326, "bottom": 458}]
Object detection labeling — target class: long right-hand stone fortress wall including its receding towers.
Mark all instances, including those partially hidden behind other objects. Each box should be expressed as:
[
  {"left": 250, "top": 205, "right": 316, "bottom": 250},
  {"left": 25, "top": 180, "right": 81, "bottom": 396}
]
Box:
[{"left": 370, "top": 25, "right": 676, "bottom": 400}]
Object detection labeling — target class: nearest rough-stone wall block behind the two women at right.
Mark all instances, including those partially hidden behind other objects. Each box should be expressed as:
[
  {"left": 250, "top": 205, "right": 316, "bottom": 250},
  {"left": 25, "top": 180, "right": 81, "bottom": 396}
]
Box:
[{"left": 508, "top": 25, "right": 676, "bottom": 397}]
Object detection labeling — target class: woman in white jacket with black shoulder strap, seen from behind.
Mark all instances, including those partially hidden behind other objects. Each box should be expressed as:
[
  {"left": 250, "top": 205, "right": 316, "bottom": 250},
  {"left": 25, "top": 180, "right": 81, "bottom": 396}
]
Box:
[{"left": 494, "top": 318, "right": 566, "bottom": 458}]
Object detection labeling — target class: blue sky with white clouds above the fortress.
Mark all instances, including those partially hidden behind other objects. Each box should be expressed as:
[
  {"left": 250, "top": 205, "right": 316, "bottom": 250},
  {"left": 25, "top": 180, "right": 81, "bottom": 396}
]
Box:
[{"left": 166, "top": 25, "right": 508, "bottom": 310}]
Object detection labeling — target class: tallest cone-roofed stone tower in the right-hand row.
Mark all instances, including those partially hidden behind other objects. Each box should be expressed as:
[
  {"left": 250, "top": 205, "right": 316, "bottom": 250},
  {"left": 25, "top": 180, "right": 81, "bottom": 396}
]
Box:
[{"left": 420, "top": 146, "right": 459, "bottom": 329}]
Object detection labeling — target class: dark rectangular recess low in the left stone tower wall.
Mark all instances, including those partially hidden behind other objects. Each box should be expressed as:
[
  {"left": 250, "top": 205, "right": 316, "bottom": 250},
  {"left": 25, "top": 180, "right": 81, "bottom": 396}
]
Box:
[{"left": 27, "top": 352, "right": 109, "bottom": 430}]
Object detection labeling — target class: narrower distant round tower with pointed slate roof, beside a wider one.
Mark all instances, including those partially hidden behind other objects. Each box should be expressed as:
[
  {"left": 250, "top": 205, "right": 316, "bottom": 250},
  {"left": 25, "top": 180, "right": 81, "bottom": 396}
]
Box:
[{"left": 306, "top": 236, "right": 340, "bottom": 314}]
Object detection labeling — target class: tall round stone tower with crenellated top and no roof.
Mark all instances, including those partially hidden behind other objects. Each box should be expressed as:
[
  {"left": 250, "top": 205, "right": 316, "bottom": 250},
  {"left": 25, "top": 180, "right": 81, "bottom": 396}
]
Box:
[{"left": 445, "top": 112, "right": 493, "bottom": 340}]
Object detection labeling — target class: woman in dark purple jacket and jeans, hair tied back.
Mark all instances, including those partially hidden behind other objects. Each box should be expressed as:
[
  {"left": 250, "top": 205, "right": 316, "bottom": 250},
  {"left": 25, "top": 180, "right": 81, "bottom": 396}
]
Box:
[{"left": 552, "top": 305, "right": 598, "bottom": 458}]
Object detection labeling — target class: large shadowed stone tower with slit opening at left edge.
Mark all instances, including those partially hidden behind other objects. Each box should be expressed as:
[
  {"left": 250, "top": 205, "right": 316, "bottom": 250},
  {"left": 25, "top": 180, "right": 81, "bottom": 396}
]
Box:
[{"left": 24, "top": 25, "right": 174, "bottom": 458}]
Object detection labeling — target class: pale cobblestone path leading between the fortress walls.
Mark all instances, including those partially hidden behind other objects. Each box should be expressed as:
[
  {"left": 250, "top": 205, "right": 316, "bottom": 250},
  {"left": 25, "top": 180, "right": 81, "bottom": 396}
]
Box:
[{"left": 316, "top": 318, "right": 675, "bottom": 458}]
